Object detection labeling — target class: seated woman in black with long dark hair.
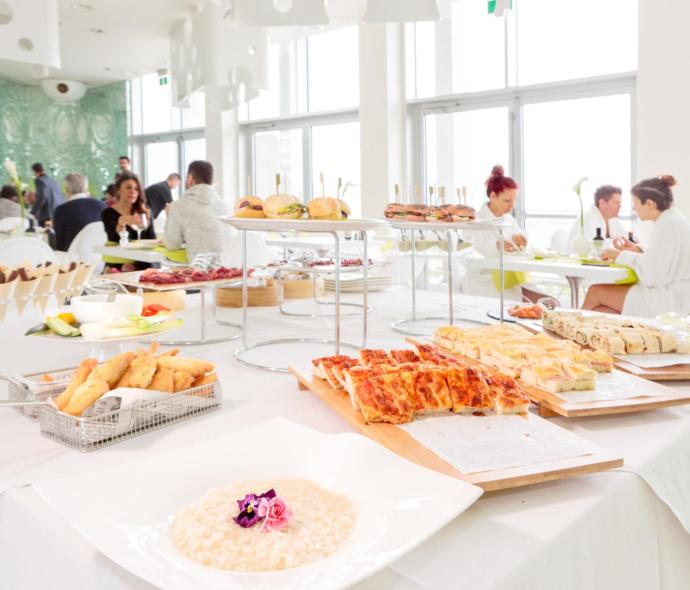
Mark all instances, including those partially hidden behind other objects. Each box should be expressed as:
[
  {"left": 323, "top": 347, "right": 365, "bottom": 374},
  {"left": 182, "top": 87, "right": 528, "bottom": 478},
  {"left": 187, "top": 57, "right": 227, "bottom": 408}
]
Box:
[{"left": 101, "top": 172, "right": 156, "bottom": 271}]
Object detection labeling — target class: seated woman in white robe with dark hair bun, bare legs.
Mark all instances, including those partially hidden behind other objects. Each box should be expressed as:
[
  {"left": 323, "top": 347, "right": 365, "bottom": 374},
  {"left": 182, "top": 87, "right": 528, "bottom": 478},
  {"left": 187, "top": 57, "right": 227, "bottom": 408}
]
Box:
[{"left": 582, "top": 176, "right": 690, "bottom": 317}]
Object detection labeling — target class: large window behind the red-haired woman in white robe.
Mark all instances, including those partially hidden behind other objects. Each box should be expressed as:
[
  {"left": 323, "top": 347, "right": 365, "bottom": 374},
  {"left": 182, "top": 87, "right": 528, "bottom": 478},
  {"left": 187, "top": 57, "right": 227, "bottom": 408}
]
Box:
[{"left": 406, "top": 0, "right": 637, "bottom": 245}]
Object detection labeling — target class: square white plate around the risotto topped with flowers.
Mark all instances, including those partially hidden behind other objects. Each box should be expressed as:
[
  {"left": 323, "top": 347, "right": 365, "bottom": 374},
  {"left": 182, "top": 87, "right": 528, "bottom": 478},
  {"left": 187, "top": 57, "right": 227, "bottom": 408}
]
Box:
[{"left": 33, "top": 420, "right": 482, "bottom": 590}]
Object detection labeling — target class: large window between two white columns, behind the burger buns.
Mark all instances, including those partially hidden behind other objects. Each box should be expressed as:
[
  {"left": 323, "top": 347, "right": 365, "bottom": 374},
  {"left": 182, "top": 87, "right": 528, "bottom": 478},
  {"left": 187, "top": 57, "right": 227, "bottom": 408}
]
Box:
[{"left": 240, "top": 26, "right": 361, "bottom": 208}]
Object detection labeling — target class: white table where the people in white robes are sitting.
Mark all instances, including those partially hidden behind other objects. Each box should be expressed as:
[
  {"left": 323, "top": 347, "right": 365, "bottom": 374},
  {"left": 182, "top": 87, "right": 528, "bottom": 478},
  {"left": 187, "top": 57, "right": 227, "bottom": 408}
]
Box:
[{"left": 466, "top": 254, "right": 629, "bottom": 309}]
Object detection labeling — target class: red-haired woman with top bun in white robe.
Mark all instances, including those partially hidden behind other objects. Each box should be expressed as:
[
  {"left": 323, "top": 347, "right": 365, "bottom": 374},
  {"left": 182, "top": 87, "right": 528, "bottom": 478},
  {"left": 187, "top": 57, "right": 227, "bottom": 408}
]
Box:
[{"left": 467, "top": 166, "right": 549, "bottom": 302}]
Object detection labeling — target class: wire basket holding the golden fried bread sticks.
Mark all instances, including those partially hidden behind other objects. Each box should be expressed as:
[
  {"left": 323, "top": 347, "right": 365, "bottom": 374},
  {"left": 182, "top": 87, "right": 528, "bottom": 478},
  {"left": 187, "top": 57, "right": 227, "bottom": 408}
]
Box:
[{"left": 2, "top": 369, "right": 222, "bottom": 452}]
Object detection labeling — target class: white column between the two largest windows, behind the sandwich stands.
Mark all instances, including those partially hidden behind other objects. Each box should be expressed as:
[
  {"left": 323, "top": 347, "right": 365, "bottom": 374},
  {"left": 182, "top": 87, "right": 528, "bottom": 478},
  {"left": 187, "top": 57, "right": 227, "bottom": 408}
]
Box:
[{"left": 359, "top": 24, "right": 407, "bottom": 217}]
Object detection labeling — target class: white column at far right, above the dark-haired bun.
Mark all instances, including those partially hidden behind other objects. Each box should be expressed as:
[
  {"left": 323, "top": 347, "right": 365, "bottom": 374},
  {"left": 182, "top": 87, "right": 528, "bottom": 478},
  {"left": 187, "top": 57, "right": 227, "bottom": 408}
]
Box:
[{"left": 635, "top": 0, "right": 690, "bottom": 217}]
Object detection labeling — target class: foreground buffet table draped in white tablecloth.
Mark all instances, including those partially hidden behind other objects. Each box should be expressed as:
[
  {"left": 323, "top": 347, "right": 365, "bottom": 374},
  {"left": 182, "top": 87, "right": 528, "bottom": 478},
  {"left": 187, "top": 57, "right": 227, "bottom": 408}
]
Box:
[{"left": 0, "top": 287, "right": 690, "bottom": 590}]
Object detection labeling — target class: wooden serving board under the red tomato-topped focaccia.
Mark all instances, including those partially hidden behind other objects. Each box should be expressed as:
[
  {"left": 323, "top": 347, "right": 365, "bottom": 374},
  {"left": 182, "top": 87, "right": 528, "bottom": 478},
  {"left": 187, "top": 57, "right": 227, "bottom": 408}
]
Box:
[{"left": 290, "top": 367, "right": 623, "bottom": 492}]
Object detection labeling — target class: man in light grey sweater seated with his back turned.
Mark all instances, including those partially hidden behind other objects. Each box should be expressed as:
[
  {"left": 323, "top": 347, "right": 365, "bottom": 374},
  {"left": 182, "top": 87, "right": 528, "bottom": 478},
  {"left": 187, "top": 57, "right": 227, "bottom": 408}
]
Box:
[{"left": 163, "top": 160, "right": 237, "bottom": 262}]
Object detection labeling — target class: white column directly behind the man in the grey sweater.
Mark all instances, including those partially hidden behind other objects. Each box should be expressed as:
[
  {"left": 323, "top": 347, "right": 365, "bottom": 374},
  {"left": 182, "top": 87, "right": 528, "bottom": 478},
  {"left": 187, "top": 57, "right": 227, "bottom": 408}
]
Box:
[{"left": 204, "top": 93, "right": 240, "bottom": 202}]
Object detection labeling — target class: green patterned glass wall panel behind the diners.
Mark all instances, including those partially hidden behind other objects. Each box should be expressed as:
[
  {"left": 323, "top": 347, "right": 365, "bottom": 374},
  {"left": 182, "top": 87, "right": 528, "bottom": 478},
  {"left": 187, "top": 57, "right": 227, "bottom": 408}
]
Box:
[{"left": 0, "top": 81, "right": 127, "bottom": 196}]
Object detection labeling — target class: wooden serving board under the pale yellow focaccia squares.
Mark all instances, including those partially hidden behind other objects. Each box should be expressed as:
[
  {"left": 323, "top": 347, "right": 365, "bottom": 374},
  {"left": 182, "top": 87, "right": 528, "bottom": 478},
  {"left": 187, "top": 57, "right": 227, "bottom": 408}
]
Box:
[{"left": 428, "top": 345, "right": 690, "bottom": 418}]
